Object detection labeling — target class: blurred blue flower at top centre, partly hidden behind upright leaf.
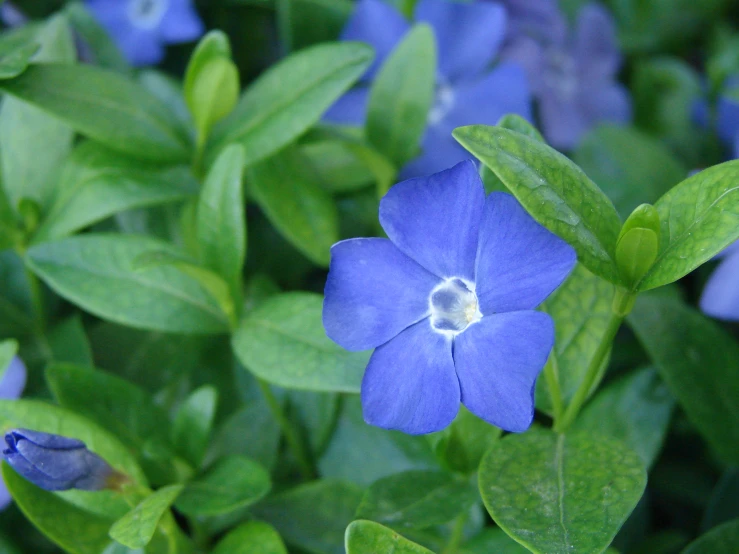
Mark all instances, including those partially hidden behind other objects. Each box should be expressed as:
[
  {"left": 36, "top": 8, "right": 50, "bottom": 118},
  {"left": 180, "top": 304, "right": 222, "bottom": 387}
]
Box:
[{"left": 325, "top": 0, "right": 531, "bottom": 177}]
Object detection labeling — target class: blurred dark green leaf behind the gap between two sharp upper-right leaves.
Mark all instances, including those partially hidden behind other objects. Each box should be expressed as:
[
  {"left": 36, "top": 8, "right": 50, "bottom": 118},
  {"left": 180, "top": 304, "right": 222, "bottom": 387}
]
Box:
[{"left": 572, "top": 125, "right": 688, "bottom": 218}]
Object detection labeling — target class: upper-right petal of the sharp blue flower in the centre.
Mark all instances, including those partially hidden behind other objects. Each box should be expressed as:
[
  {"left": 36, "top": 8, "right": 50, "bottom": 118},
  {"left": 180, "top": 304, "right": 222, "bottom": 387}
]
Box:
[{"left": 475, "top": 192, "right": 577, "bottom": 315}]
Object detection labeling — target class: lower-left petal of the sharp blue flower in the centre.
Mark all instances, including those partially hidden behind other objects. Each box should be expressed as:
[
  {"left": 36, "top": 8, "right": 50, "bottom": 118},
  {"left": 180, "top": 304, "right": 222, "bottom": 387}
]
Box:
[{"left": 362, "top": 320, "right": 459, "bottom": 435}]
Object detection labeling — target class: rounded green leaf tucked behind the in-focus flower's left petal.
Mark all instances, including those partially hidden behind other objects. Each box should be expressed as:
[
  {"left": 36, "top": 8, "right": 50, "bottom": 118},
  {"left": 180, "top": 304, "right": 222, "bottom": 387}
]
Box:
[{"left": 232, "top": 292, "right": 368, "bottom": 392}]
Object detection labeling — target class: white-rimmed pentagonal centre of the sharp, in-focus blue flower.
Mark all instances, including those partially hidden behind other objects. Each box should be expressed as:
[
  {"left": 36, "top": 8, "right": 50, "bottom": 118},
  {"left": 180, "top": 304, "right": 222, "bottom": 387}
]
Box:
[{"left": 429, "top": 277, "right": 482, "bottom": 336}]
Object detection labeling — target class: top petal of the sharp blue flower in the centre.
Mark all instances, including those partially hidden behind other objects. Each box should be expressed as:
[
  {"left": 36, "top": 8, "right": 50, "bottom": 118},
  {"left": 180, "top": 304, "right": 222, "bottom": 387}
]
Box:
[{"left": 380, "top": 160, "right": 485, "bottom": 281}]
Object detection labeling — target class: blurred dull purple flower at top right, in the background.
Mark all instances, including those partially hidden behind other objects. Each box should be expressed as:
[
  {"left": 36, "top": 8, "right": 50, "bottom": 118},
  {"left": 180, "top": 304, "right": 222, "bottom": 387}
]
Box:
[{"left": 503, "top": 0, "right": 631, "bottom": 150}]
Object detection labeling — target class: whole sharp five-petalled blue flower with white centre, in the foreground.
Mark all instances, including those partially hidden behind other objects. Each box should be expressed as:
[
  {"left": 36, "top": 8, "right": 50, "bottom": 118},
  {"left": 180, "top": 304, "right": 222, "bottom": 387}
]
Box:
[{"left": 323, "top": 160, "right": 576, "bottom": 434}]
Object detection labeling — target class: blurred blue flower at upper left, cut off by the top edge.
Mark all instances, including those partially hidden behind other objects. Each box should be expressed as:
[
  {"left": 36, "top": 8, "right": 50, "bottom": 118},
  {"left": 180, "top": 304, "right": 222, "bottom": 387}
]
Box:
[{"left": 85, "top": 0, "right": 204, "bottom": 65}]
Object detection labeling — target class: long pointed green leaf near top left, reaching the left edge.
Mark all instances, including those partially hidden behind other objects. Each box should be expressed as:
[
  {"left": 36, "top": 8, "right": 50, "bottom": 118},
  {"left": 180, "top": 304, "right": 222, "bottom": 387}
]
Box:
[{"left": 0, "top": 64, "right": 189, "bottom": 162}]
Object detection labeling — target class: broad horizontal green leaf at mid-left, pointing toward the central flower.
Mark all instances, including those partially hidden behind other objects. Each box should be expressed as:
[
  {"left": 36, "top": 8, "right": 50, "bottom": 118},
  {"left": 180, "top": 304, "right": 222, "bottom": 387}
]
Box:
[{"left": 27, "top": 234, "right": 229, "bottom": 333}]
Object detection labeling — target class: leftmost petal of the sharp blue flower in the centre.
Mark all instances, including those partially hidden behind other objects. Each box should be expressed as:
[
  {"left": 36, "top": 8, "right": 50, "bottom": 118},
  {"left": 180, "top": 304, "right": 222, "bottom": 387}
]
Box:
[{"left": 323, "top": 238, "right": 439, "bottom": 350}]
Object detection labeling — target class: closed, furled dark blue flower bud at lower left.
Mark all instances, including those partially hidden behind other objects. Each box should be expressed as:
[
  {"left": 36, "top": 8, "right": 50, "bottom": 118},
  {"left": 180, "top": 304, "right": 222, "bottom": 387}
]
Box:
[{"left": 3, "top": 429, "right": 115, "bottom": 491}]
